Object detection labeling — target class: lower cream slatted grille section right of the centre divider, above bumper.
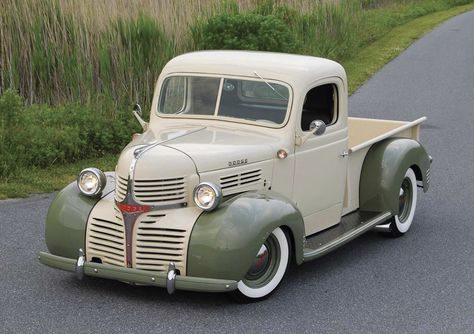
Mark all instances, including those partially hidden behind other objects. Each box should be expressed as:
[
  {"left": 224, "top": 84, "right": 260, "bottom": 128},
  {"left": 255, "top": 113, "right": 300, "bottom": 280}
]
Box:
[{"left": 133, "top": 213, "right": 189, "bottom": 275}]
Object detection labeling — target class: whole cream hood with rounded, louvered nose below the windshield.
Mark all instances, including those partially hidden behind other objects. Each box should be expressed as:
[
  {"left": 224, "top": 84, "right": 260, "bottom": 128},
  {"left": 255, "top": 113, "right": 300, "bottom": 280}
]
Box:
[{"left": 116, "top": 127, "right": 279, "bottom": 205}]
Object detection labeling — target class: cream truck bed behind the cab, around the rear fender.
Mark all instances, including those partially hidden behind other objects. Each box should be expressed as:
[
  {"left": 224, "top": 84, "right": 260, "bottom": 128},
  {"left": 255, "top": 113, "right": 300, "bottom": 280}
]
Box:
[{"left": 343, "top": 117, "right": 426, "bottom": 215}]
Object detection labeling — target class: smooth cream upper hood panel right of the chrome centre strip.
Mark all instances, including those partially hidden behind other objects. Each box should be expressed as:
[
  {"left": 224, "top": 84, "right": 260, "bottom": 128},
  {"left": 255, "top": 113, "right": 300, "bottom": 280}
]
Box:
[{"left": 162, "top": 127, "right": 278, "bottom": 172}]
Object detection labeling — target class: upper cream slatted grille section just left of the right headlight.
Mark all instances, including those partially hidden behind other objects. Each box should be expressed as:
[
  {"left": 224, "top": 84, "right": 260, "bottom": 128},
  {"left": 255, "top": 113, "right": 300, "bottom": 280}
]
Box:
[{"left": 133, "top": 177, "right": 188, "bottom": 205}]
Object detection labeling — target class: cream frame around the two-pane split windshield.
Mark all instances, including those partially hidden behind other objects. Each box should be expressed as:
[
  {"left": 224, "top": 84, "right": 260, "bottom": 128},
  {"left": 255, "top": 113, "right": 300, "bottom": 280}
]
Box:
[{"left": 154, "top": 72, "right": 294, "bottom": 129}]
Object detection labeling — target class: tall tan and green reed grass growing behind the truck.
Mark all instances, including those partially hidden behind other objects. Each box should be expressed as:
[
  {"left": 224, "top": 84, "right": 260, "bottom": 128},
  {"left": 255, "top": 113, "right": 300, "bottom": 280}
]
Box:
[{"left": 0, "top": 0, "right": 470, "bottom": 106}]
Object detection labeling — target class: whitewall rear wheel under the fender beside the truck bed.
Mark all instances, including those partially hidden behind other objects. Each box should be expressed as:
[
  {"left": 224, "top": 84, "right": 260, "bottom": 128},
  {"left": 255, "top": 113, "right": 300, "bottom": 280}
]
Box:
[{"left": 390, "top": 168, "right": 417, "bottom": 237}]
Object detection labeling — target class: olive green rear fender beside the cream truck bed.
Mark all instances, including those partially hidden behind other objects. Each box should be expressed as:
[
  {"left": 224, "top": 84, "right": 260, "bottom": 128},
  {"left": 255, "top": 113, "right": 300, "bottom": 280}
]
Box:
[{"left": 359, "top": 138, "right": 430, "bottom": 215}]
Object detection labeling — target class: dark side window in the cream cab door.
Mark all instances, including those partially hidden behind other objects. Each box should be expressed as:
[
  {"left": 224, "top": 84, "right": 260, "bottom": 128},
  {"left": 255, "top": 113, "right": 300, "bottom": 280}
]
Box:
[{"left": 301, "top": 84, "right": 338, "bottom": 131}]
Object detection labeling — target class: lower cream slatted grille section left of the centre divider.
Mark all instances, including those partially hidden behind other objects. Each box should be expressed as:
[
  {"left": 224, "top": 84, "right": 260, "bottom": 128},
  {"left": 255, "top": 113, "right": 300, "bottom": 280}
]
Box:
[{"left": 86, "top": 208, "right": 126, "bottom": 266}]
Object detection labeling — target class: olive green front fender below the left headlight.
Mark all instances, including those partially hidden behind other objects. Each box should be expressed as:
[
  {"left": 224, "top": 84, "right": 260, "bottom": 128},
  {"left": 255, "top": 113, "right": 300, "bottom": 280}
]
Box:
[{"left": 45, "top": 173, "right": 115, "bottom": 259}]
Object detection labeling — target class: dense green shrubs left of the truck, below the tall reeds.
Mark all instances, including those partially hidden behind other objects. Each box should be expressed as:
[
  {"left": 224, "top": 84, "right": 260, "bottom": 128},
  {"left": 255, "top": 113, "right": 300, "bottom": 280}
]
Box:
[{"left": 0, "top": 91, "right": 138, "bottom": 177}]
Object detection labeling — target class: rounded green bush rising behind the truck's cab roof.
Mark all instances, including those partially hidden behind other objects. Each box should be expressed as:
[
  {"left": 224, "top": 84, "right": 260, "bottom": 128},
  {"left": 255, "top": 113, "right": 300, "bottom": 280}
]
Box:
[{"left": 192, "top": 13, "right": 296, "bottom": 52}]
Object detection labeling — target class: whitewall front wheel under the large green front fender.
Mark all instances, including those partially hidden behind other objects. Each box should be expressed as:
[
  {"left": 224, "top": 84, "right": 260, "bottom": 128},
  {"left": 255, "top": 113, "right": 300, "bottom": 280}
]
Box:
[{"left": 233, "top": 227, "right": 290, "bottom": 303}]
